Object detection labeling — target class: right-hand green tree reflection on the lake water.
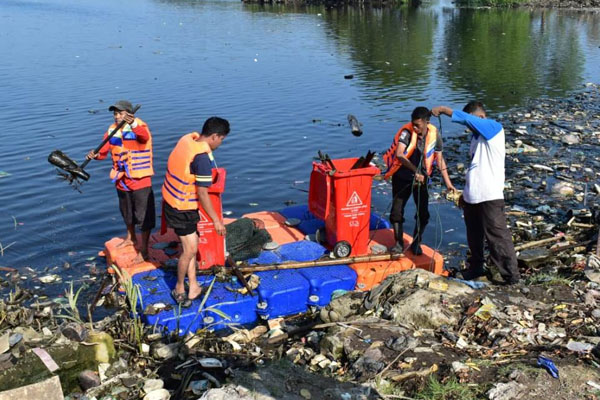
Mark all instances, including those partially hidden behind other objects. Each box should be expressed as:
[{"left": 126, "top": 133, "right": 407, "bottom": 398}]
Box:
[{"left": 441, "top": 9, "right": 583, "bottom": 109}]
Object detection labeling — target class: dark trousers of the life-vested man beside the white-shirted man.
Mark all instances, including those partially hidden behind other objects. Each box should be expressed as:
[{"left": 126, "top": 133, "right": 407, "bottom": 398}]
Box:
[{"left": 390, "top": 175, "right": 429, "bottom": 235}]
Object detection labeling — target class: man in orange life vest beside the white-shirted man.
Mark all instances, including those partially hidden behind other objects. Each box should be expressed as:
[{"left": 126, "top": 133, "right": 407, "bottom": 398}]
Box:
[{"left": 383, "top": 107, "right": 456, "bottom": 255}]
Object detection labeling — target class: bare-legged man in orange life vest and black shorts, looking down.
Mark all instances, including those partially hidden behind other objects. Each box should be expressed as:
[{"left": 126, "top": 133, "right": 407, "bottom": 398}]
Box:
[{"left": 162, "top": 117, "right": 229, "bottom": 305}]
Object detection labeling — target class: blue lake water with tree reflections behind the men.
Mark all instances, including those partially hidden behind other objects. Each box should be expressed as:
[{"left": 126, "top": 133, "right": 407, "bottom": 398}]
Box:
[{"left": 0, "top": 0, "right": 600, "bottom": 282}]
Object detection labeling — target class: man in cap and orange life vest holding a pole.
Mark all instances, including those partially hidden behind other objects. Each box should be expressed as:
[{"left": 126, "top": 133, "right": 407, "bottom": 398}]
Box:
[{"left": 87, "top": 100, "right": 156, "bottom": 259}]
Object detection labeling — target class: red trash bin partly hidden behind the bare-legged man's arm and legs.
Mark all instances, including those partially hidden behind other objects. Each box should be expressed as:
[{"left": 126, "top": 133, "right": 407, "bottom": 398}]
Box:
[{"left": 197, "top": 168, "right": 227, "bottom": 269}]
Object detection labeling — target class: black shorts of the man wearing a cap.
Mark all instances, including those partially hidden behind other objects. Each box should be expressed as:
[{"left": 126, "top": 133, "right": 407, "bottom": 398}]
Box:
[{"left": 117, "top": 187, "right": 156, "bottom": 231}]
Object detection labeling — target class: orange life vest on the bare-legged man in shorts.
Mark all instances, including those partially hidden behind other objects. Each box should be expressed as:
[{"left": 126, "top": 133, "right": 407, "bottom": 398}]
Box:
[{"left": 162, "top": 132, "right": 216, "bottom": 211}]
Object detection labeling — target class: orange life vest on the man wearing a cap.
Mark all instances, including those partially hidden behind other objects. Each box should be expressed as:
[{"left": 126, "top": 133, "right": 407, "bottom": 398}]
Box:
[{"left": 108, "top": 118, "right": 154, "bottom": 182}]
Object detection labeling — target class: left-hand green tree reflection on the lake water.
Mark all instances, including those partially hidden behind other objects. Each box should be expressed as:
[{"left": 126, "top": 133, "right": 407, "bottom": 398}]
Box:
[{"left": 326, "top": 7, "right": 438, "bottom": 101}]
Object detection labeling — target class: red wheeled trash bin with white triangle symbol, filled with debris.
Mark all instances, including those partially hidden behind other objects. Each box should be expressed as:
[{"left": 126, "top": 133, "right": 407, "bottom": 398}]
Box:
[{"left": 308, "top": 158, "right": 380, "bottom": 257}]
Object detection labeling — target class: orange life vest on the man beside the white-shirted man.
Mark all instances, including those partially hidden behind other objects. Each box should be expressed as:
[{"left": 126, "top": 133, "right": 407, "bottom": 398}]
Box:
[{"left": 383, "top": 122, "right": 437, "bottom": 179}]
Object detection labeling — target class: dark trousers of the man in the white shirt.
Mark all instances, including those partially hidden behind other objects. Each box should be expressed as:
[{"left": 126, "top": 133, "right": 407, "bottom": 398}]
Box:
[{"left": 463, "top": 200, "right": 520, "bottom": 282}]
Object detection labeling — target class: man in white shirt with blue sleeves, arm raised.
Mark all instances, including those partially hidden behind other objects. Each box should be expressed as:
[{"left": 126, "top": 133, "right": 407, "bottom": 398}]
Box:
[{"left": 431, "top": 101, "right": 520, "bottom": 284}]
